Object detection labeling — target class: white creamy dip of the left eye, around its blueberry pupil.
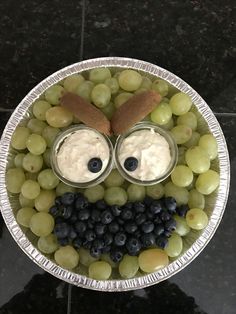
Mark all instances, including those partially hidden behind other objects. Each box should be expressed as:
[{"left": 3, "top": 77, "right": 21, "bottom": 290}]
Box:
[{"left": 56, "top": 130, "right": 110, "bottom": 183}]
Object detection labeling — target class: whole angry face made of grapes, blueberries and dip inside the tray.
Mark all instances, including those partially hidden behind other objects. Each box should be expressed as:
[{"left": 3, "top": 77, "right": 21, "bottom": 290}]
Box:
[{"left": 6, "top": 68, "right": 219, "bottom": 280}]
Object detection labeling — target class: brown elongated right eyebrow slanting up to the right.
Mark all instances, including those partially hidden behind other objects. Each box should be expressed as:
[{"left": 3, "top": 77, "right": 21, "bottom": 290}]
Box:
[{"left": 111, "top": 91, "right": 161, "bottom": 135}]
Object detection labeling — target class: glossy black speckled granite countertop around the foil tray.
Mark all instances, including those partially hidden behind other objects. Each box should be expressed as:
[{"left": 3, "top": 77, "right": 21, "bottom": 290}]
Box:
[{"left": 0, "top": 0, "right": 236, "bottom": 314}]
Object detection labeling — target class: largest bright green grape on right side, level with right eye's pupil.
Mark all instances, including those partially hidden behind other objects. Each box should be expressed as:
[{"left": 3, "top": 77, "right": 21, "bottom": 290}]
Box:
[{"left": 185, "top": 146, "right": 210, "bottom": 173}]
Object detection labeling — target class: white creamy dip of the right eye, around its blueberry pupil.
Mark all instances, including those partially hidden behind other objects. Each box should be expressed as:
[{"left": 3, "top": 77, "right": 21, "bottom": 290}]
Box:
[{"left": 118, "top": 129, "right": 171, "bottom": 181}]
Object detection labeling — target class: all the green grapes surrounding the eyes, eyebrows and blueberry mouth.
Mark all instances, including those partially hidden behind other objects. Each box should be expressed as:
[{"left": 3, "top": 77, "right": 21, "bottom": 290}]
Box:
[{"left": 6, "top": 68, "right": 219, "bottom": 279}]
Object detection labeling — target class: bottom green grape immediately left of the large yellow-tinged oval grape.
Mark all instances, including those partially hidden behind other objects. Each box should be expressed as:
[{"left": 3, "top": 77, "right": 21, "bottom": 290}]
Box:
[{"left": 119, "top": 254, "right": 139, "bottom": 279}]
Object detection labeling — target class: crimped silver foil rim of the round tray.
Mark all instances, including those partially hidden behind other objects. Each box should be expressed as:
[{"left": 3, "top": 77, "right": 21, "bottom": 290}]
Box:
[{"left": 0, "top": 57, "right": 230, "bottom": 291}]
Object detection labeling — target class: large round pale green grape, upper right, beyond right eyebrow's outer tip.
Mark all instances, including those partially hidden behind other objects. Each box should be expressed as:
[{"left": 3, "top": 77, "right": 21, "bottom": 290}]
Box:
[{"left": 170, "top": 92, "right": 192, "bottom": 116}]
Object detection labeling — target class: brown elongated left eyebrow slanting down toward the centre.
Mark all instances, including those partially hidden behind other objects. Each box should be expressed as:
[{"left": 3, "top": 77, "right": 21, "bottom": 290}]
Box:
[{"left": 60, "top": 93, "right": 112, "bottom": 135}]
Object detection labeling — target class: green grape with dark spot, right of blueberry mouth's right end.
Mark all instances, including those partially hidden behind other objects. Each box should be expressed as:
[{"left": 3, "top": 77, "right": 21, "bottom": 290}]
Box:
[{"left": 186, "top": 208, "right": 208, "bottom": 230}]
